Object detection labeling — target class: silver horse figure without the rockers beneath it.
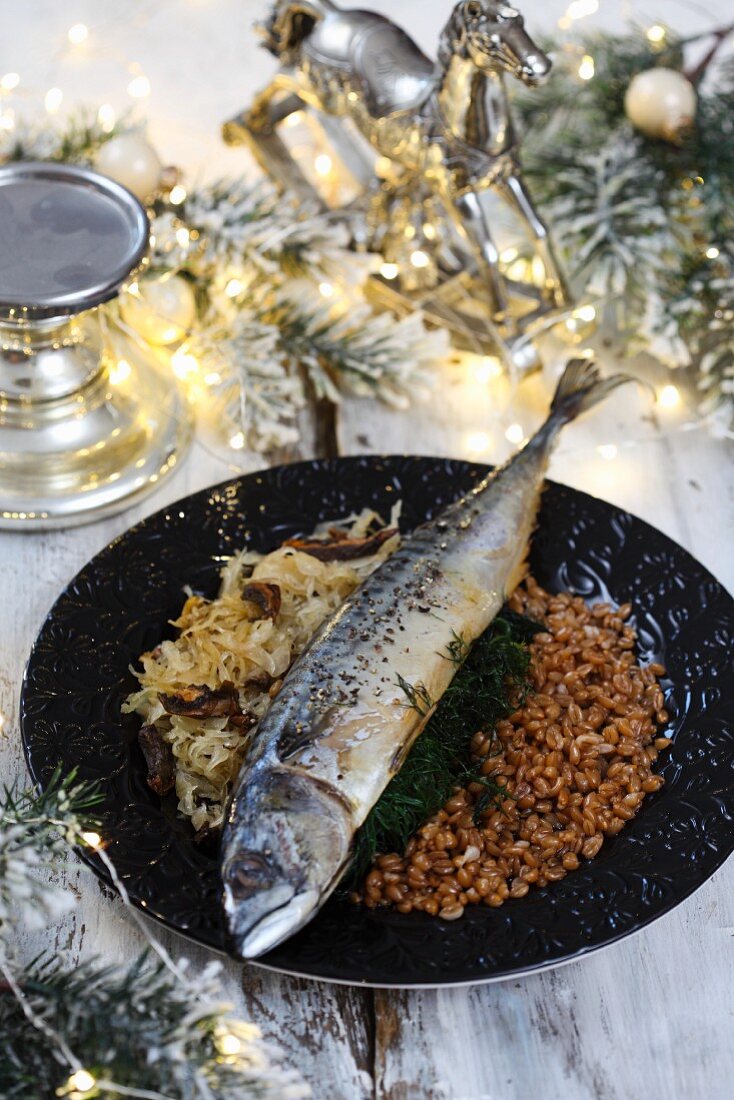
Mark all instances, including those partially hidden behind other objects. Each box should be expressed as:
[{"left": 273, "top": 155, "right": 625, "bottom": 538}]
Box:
[{"left": 232, "top": 0, "right": 568, "bottom": 319}]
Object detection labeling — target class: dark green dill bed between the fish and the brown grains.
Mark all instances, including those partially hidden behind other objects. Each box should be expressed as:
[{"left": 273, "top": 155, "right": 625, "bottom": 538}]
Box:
[{"left": 346, "top": 611, "right": 540, "bottom": 888}]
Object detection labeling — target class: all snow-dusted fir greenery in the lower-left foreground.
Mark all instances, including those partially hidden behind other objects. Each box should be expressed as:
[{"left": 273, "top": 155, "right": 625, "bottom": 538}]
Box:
[{"left": 0, "top": 774, "right": 310, "bottom": 1100}]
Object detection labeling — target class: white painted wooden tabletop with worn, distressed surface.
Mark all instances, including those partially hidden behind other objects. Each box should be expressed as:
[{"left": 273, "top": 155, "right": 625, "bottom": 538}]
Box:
[{"left": 0, "top": 0, "right": 734, "bottom": 1100}]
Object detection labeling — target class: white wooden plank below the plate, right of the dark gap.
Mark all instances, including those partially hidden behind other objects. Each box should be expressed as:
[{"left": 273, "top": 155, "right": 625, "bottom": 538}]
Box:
[{"left": 375, "top": 862, "right": 734, "bottom": 1100}]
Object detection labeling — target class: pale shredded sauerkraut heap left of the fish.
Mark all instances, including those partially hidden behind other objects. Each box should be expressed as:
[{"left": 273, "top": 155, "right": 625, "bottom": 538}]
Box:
[{"left": 122, "top": 505, "right": 399, "bottom": 833}]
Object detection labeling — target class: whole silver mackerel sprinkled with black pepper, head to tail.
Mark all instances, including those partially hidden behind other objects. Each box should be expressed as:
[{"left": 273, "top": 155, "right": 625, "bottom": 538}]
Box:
[{"left": 221, "top": 360, "right": 631, "bottom": 958}]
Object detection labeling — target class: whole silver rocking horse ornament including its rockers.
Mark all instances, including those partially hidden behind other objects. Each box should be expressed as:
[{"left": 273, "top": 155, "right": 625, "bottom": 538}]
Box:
[{"left": 224, "top": 0, "right": 570, "bottom": 366}]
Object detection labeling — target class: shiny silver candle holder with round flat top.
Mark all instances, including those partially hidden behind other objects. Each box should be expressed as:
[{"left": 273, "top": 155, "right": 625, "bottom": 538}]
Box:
[{"left": 0, "top": 163, "right": 191, "bottom": 528}]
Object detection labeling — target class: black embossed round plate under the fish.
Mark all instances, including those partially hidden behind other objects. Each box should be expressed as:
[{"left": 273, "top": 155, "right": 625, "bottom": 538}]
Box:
[{"left": 17, "top": 458, "right": 734, "bottom": 987}]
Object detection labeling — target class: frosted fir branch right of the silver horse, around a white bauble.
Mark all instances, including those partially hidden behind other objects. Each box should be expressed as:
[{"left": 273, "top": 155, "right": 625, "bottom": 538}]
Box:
[{"left": 515, "top": 31, "right": 734, "bottom": 432}]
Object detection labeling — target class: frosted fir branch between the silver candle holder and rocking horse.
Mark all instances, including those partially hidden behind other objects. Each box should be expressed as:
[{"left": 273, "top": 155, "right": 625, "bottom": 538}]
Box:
[{"left": 153, "top": 182, "right": 446, "bottom": 451}]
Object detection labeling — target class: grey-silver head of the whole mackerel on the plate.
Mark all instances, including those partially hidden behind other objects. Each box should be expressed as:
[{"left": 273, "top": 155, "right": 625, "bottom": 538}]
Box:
[{"left": 221, "top": 768, "right": 353, "bottom": 958}]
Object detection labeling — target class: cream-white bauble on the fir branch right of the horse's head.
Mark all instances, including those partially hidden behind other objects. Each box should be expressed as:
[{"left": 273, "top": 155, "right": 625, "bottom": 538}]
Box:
[{"left": 624, "top": 68, "right": 698, "bottom": 142}]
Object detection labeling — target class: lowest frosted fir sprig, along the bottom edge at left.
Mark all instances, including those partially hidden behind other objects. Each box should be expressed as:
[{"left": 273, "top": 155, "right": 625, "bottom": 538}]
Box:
[{"left": 0, "top": 955, "right": 310, "bottom": 1100}]
